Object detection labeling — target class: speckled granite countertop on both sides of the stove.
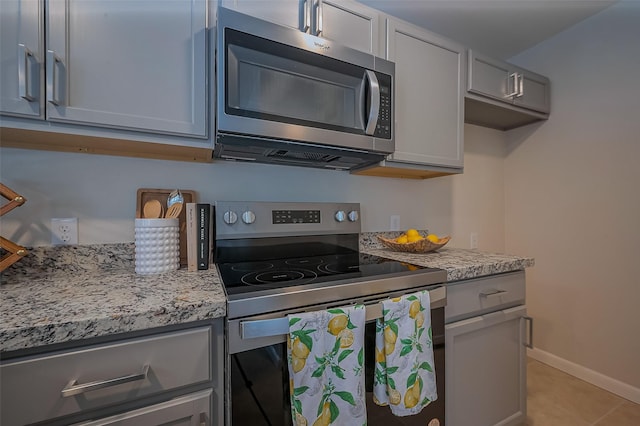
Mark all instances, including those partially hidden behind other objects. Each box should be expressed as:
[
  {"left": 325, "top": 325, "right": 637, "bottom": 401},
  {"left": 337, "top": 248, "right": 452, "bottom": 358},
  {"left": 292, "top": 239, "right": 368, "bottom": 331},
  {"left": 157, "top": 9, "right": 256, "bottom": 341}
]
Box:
[{"left": 0, "top": 238, "right": 534, "bottom": 353}]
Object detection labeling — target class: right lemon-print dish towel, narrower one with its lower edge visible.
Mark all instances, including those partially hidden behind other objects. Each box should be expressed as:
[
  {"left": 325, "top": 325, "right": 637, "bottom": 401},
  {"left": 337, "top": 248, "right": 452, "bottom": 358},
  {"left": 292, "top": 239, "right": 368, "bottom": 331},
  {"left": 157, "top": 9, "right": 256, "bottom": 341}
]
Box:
[{"left": 373, "top": 291, "right": 438, "bottom": 416}]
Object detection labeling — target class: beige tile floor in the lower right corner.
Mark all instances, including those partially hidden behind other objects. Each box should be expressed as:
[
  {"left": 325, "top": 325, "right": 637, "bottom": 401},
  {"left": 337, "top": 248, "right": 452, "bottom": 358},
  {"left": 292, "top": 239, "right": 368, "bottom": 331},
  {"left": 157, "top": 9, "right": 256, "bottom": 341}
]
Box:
[{"left": 526, "top": 358, "right": 640, "bottom": 426}]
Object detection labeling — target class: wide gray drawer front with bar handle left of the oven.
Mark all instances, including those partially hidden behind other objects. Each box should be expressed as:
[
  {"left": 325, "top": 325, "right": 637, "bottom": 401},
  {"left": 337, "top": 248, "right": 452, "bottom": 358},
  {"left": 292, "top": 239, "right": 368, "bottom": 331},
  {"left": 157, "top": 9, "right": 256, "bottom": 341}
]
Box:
[{"left": 0, "top": 327, "right": 212, "bottom": 425}]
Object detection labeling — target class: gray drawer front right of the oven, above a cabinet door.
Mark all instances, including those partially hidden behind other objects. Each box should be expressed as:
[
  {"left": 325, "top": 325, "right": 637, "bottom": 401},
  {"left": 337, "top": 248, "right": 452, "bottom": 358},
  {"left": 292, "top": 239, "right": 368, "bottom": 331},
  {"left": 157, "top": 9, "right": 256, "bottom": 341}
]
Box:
[{"left": 445, "top": 271, "right": 525, "bottom": 323}]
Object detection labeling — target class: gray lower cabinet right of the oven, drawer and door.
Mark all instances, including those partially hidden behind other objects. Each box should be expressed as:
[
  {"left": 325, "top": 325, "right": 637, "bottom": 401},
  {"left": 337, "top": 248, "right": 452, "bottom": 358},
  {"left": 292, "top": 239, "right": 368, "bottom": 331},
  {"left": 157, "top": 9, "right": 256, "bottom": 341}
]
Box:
[{"left": 445, "top": 271, "right": 531, "bottom": 426}]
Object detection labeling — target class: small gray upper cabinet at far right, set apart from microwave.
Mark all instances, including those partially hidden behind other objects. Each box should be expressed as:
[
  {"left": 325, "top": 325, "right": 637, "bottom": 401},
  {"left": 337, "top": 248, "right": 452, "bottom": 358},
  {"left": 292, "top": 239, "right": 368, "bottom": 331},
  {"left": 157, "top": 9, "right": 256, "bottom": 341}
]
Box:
[{"left": 465, "top": 50, "right": 551, "bottom": 130}]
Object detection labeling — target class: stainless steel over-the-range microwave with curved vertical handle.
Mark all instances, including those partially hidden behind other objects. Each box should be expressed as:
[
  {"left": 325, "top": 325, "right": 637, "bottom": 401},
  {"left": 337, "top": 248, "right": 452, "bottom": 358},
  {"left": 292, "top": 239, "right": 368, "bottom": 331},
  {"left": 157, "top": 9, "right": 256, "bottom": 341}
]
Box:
[{"left": 214, "top": 8, "right": 395, "bottom": 169}]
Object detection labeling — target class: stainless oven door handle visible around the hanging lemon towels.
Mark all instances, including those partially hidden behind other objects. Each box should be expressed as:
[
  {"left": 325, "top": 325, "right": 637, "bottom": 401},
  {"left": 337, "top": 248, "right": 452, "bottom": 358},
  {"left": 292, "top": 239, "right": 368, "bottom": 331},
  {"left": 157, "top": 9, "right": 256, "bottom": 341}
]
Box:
[{"left": 240, "top": 287, "right": 447, "bottom": 339}]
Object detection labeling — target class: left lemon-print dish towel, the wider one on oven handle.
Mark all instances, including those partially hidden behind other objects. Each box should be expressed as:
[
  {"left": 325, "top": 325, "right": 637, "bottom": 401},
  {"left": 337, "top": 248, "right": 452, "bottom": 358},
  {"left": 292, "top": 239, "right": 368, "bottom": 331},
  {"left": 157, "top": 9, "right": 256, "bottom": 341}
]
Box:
[{"left": 287, "top": 305, "right": 367, "bottom": 426}]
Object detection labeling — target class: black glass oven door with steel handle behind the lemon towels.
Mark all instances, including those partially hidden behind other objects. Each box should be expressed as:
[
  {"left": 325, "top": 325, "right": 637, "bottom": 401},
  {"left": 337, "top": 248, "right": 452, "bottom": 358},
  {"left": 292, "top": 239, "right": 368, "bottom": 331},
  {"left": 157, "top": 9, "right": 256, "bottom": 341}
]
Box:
[{"left": 226, "top": 287, "right": 446, "bottom": 426}]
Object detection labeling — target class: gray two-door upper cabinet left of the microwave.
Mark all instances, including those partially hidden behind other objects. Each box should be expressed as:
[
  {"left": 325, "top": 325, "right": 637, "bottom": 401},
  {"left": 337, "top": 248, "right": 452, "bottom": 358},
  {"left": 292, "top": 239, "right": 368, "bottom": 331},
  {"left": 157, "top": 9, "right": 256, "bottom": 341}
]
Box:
[{"left": 2, "top": 0, "right": 208, "bottom": 138}]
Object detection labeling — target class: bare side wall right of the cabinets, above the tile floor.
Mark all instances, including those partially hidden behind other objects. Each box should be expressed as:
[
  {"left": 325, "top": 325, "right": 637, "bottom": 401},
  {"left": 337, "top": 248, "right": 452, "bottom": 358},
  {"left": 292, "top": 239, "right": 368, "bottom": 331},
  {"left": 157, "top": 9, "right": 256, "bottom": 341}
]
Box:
[{"left": 505, "top": 2, "right": 640, "bottom": 401}]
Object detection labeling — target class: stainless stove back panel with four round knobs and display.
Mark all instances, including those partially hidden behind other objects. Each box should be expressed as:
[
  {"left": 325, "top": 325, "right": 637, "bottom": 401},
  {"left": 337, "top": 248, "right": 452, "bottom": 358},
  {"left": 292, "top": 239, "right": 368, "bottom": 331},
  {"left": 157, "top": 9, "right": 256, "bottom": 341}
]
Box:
[{"left": 215, "top": 201, "right": 360, "bottom": 239}]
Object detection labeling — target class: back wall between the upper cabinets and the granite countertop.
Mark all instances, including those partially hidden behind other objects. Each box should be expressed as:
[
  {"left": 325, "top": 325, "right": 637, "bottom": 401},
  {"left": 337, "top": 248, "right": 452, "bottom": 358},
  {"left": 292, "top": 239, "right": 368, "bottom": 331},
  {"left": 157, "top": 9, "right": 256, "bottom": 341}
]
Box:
[{"left": 0, "top": 126, "right": 506, "bottom": 251}]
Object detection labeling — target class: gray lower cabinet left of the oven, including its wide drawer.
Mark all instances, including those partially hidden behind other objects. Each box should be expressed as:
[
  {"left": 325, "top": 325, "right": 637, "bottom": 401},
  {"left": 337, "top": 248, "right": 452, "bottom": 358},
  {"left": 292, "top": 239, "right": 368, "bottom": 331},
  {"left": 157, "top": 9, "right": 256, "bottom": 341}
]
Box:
[{"left": 0, "top": 320, "right": 224, "bottom": 425}]
